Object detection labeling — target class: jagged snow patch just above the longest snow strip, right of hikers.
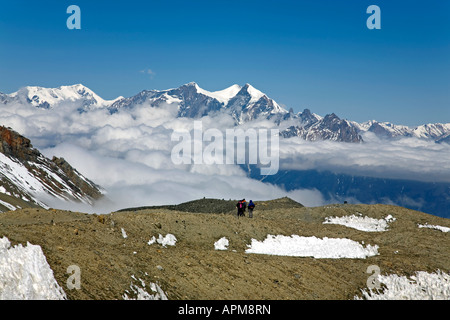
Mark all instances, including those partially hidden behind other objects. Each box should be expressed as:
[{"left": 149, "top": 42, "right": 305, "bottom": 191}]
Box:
[{"left": 324, "top": 213, "right": 396, "bottom": 232}]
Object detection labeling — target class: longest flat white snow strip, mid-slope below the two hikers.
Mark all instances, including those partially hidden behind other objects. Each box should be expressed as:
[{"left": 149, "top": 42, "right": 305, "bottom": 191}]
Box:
[{"left": 245, "top": 235, "right": 378, "bottom": 259}]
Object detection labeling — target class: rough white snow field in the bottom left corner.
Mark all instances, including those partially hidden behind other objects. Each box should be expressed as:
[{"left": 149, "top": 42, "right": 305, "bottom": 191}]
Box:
[{"left": 0, "top": 237, "right": 66, "bottom": 300}]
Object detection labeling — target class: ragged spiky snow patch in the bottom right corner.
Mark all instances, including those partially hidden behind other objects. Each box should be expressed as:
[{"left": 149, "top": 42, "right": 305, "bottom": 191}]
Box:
[{"left": 355, "top": 271, "right": 450, "bottom": 300}]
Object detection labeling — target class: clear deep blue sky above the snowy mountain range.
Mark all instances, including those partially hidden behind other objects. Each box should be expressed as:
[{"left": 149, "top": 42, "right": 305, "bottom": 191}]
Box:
[{"left": 0, "top": 0, "right": 450, "bottom": 126}]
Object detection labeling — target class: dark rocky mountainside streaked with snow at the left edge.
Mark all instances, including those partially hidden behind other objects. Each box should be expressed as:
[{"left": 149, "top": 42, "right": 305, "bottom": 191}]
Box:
[{"left": 0, "top": 127, "right": 102, "bottom": 210}]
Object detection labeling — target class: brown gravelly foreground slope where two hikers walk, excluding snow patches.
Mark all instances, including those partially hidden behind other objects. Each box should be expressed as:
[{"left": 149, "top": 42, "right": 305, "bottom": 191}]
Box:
[{"left": 0, "top": 198, "right": 450, "bottom": 300}]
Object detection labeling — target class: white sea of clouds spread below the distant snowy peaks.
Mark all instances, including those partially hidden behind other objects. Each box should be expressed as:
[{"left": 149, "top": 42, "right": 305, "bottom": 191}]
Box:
[{"left": 0, "top": 97, "right": 450, "bottom": 212}]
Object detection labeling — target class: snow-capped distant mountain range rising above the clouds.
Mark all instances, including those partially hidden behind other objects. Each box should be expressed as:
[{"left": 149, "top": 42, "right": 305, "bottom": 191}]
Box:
[{"left": 0, "top": 82, "right": 450, "bottom": 143}]
